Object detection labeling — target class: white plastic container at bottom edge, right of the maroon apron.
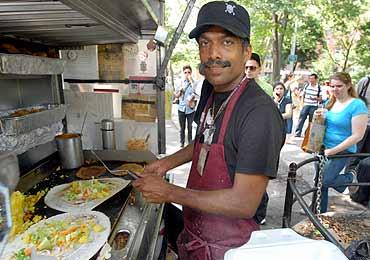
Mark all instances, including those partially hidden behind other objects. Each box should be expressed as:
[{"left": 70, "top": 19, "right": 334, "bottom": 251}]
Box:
[{"left": 224, "top": 228, "right": 348, "bottom": 260}]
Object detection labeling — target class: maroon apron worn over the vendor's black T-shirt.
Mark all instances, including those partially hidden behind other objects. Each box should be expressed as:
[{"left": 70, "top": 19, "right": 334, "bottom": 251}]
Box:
[{"left": 177, "top": 80, "right": 259, "bottom": 260}]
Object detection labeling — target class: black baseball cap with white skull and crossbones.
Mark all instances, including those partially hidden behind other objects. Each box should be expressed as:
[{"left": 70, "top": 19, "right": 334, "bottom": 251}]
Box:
[{"left": 189, "top": 1, "right": 251, "bottom": 39}]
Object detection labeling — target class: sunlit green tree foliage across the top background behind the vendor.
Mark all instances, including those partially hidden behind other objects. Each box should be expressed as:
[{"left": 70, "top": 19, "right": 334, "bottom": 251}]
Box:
[{"left": 167, "top": 0, "right": 370, "bottom": 78}]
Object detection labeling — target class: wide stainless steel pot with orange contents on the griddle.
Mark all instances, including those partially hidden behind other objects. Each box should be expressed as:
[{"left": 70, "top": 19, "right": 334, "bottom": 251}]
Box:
[{"left": 55, "top": 133, "right": 84, "bottom": 169}]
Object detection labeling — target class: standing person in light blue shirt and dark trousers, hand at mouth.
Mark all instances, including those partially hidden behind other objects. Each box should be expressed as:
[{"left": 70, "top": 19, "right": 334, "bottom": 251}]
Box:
[{"left": 175, "top": 65, "right": 196, "bottom": 147}]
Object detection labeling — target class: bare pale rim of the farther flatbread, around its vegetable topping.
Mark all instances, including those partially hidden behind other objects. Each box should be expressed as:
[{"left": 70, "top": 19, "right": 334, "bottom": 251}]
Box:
[{"left": 44, "top": 178, "right": 130, "bottom": 212}]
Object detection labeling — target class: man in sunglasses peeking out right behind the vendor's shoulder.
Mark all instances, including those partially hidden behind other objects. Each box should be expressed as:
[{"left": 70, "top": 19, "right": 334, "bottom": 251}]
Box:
[{"left": 245, "top": 53, "right": 273, "bottom": 97}]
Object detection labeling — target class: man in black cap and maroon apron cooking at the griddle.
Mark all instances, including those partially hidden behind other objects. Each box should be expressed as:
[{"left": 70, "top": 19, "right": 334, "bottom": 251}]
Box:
[{"left": 133, "top": 1, "right": 284, "bottom": 260}]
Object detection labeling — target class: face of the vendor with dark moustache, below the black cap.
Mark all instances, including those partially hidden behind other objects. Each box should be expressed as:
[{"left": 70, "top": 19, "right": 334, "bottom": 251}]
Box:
[{"left": 198, "top": 26, "right": 251, "bottom": 92}]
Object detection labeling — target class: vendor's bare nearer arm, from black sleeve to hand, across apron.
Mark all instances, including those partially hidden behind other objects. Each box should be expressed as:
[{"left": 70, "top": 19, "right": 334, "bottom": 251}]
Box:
[{"left": 133, "top": 173, "right": 269, "bottom": 218}]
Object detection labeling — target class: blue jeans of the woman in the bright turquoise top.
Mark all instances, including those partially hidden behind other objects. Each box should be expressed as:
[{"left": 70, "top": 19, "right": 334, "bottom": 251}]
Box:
[{"left": 320, "top": 158, "right": 353, "bottom": 213}]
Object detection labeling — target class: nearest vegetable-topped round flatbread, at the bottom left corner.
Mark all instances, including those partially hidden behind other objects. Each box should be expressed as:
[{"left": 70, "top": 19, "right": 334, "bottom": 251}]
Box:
[{"left": 1, "top": 211, "right": 111, "bottom": 260}]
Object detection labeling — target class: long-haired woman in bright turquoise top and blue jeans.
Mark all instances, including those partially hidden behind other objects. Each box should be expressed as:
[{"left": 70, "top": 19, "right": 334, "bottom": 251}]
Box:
[{"left": 315, "top": 72, "right": 368, "bottom": 213}]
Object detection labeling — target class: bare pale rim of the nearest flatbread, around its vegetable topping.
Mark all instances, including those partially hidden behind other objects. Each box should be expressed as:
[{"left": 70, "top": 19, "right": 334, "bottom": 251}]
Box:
[{"left": 1, "top": 211, "right": 111, "bottom": 260}]
